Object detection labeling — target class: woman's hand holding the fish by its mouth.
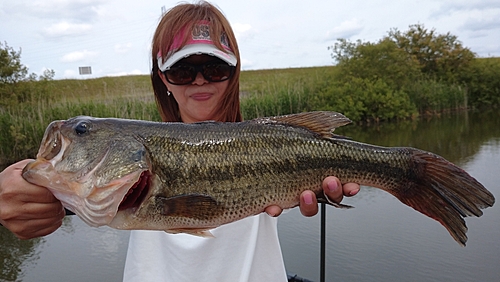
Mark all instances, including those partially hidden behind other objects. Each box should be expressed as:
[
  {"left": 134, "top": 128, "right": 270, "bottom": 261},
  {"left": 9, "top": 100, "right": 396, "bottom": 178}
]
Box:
[{"left": 0, "top": 160, "right": 65, "bottom": 239}]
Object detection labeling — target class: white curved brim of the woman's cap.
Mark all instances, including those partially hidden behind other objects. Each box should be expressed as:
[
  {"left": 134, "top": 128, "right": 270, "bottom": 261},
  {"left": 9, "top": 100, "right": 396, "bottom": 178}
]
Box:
[{"left": 158, "top": 44, "right": 238, "bottom": 72}]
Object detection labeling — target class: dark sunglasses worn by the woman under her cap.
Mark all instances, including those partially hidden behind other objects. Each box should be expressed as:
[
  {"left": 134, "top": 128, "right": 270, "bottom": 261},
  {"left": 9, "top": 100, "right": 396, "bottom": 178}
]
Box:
[{"left": 163, "top": 61, "right": 236, "bottom": 85}]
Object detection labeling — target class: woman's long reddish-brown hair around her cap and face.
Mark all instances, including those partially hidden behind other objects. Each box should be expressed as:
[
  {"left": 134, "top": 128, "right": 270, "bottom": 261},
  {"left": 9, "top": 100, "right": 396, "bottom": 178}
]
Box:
[{"left": 151, "top": 1, "right": 242, "bottom": 122}]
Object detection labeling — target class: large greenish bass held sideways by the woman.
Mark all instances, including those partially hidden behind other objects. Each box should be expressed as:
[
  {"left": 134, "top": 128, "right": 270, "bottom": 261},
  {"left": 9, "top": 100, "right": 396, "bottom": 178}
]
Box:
[{"left": 23, "top": 112, "right": 495, "bottom": 245}]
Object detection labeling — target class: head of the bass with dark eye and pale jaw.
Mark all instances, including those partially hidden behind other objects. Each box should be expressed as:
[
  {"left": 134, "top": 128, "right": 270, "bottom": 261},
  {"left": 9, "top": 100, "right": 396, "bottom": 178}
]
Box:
[{"left": 23, "top": 116, "right": 149, "bottom": 226}]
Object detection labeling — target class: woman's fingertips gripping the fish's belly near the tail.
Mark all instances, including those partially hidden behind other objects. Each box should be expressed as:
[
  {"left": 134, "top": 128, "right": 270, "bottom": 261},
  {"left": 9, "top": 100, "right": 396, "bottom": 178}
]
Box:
[{"left": 266, "top": 176, "right": 359, "bottom": 216}]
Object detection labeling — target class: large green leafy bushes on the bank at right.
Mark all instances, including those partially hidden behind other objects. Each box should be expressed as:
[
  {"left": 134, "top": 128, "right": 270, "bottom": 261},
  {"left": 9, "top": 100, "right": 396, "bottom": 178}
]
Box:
[{"left": 315, "top": 24, "right": 500, "bottom": 120}]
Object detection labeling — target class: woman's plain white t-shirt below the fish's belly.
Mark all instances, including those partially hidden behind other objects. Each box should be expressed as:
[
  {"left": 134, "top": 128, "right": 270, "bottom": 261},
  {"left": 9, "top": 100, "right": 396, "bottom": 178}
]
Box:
[{"left": 123, "top": 213, "right": 287, "bottom": 282}]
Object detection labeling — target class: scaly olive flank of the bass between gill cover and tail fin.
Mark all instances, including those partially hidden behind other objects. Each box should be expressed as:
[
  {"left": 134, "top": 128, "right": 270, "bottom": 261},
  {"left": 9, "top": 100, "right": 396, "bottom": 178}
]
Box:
[{"left": 114, "top": 123, "right": 430, "bottom": 230}]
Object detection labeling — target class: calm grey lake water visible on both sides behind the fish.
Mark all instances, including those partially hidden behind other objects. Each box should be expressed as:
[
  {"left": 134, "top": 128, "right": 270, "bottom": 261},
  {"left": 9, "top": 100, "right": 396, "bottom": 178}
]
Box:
[{"left": 0, "top": 109, "right": 500, "bottom": 282}]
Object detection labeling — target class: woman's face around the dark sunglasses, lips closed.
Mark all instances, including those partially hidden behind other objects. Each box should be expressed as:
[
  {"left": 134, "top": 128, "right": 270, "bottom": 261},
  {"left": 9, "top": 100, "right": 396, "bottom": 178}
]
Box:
[{"left": 160, "top": 55, "right": 229, "bottom": 123}]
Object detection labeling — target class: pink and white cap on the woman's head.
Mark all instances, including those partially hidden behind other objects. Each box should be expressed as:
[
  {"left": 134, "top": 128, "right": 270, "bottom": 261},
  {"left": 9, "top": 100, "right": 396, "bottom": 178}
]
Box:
[{"left": 157, "top": 21, "right": 238, "bottom": 72}]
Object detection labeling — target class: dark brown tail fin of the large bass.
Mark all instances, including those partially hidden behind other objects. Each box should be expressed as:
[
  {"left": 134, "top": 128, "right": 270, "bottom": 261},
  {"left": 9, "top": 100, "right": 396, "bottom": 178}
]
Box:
[{"left": 389, "top": 148, "right": 495, "bottom": 246}]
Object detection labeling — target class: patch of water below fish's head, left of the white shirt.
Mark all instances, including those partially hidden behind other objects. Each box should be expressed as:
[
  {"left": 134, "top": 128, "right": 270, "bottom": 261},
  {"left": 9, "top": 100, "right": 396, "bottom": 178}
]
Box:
[{"left": 0, "top": 216, "right": 129, "bottom": 282}]
